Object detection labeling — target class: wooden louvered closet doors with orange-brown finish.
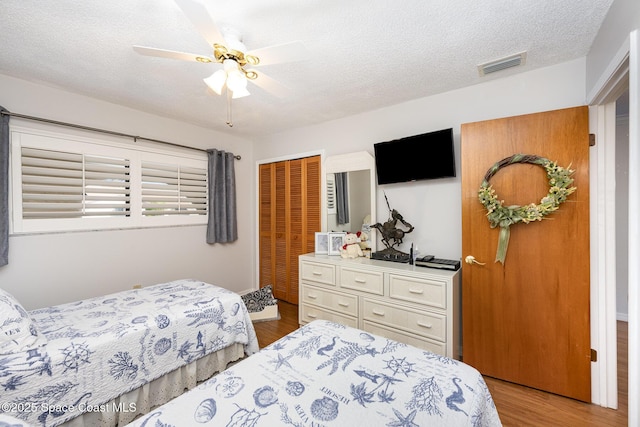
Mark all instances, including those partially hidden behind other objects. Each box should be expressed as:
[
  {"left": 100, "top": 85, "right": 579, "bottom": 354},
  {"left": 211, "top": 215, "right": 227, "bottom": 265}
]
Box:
[{"left": 258, "top": 156, "right": 321, "bottom": 305}]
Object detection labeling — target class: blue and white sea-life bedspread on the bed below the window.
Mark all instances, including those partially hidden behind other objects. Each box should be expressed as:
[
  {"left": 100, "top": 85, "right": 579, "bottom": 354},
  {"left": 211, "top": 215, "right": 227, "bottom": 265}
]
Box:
[{"left": 0, "top": 280, "right": 258, "bottom": 426}]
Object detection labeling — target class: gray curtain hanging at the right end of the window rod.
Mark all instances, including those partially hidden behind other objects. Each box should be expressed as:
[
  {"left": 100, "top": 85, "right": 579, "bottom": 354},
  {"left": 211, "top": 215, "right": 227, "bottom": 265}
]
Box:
[{"left": 207, "top": 150, "right": 238, "bottom": 244}]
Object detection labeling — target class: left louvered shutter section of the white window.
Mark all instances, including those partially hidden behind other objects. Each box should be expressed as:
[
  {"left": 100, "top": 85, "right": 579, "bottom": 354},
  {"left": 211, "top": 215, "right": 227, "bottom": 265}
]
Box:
[{"left": 21, "top": 147, "right": 131, "bottom": 219}]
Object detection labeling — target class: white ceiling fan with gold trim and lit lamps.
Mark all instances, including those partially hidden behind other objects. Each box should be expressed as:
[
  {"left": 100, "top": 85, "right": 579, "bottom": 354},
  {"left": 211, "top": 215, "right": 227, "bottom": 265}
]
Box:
[{"left": 133, "top": 0, "right": 307, "bottom": 126}]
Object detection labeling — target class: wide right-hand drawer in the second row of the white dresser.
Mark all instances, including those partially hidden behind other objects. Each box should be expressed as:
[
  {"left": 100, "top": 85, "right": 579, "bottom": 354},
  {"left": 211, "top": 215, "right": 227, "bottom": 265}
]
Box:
[{"left": 362, "top": 298, "right": 447, "bottom": 342}]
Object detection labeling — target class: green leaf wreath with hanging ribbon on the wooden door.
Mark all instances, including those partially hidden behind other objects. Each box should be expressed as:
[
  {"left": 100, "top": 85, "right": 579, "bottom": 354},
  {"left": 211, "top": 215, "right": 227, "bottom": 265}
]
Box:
[{"left": 478, "top": 154, "right": 576, "bottom": 264}]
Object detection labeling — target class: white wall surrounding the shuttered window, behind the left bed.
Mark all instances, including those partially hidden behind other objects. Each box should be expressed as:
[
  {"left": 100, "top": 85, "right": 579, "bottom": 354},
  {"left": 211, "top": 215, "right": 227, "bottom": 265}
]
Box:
[{"left": 0, "top": 75, "right": 255, "bottom": 310}]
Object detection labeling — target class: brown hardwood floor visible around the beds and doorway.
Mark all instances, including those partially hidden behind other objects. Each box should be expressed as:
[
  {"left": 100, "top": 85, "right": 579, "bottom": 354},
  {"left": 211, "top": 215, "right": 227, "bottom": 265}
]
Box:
[{"left": 254, "top": 301, "right": 628, "bottom": 427}]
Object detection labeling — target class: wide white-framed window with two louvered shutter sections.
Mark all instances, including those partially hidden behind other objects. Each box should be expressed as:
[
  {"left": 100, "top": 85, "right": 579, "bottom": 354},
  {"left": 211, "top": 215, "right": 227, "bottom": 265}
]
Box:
[{"left": 11, "top": 128, "right": 207, "bottom": 233}]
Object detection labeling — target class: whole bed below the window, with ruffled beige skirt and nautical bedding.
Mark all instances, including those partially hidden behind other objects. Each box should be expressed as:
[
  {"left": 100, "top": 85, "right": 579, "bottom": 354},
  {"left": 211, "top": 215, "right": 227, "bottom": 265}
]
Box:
[{"left": 0, "top": 280, "right": 258, "bottom": 426}]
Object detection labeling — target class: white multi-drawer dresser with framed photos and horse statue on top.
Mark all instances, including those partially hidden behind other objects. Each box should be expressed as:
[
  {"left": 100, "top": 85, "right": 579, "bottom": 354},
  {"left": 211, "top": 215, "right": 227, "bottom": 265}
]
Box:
[{"left": 298, "top": 253, "right": 461, "bottom": 359}]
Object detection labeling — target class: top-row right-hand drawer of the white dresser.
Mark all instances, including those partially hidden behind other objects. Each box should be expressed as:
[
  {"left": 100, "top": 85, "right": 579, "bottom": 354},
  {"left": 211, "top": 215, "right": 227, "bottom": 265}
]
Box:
[{"left": 389, "top": 274, "right": 447, "bottom": 309}]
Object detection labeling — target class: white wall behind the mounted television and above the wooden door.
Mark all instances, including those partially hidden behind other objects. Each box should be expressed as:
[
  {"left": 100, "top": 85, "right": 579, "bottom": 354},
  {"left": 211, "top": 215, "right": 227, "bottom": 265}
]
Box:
[{"left": 254, "top": 58, "right": 585, "bottom": 261}]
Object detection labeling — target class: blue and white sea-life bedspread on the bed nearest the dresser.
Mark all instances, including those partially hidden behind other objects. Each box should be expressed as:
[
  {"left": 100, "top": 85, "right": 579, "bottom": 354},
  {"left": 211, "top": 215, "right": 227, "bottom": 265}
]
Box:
[{"left": 131, "top": 320, "right": 501, "bottom": 427}]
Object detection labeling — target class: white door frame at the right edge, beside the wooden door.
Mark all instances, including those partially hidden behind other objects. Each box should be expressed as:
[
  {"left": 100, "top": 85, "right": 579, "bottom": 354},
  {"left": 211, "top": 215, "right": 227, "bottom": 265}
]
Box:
[{"left": 587, "top": 30, "right": 640, "bottom": 418}]
